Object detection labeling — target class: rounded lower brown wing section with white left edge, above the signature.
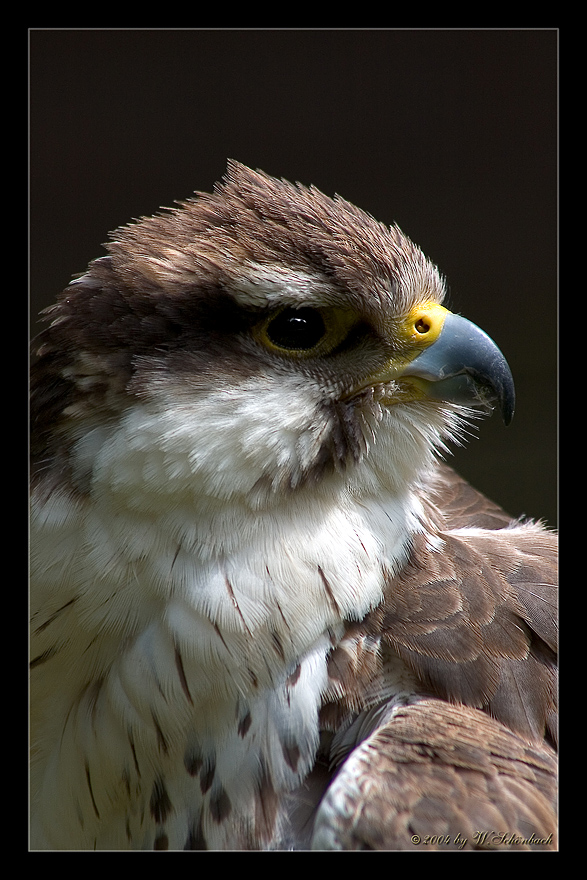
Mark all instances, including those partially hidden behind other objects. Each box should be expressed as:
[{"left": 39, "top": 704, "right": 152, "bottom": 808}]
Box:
[{"left": 314, "top": 699, "right": 556, "bottom": 852}]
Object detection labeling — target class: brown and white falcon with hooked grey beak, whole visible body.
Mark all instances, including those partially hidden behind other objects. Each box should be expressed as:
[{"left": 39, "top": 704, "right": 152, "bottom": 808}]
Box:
[{"left": 30, "top": 162, "right": 557, "bottom": 852}]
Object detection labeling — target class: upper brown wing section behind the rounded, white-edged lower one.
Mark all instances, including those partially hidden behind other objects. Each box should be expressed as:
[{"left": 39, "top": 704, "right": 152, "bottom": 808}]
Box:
[{"left": 371, "top": 512, "right": 557, "bottom": 739}]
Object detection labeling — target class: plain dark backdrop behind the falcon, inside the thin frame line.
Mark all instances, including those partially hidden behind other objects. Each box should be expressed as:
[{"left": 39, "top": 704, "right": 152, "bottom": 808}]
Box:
[{"left": 30, "top": 29, "right": 558, "bottom": 526}]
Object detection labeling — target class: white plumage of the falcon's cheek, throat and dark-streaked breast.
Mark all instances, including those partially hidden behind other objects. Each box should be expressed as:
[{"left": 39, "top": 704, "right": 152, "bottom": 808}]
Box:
[{"left": 31, "top": 388, "right": 428, "bottom": 846}]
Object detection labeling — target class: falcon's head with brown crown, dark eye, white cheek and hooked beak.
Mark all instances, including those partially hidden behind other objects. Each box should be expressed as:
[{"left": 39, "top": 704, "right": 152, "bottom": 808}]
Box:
[{"left": 32, "top": 162, "right": 514, "bottom": 505}]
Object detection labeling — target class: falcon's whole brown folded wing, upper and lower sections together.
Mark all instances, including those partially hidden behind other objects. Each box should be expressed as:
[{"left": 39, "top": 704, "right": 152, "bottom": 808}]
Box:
[{"left": 314, "top": 478, "right": 558, "bottom": 850}]
